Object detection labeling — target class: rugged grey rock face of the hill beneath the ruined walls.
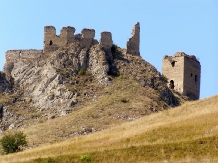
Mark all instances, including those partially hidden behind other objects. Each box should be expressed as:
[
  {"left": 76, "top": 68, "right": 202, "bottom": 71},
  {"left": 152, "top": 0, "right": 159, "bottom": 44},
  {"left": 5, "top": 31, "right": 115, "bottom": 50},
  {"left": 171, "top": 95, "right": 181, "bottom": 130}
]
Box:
[{"left": 0, "top": 40, "right": 182, "bottom": 134}]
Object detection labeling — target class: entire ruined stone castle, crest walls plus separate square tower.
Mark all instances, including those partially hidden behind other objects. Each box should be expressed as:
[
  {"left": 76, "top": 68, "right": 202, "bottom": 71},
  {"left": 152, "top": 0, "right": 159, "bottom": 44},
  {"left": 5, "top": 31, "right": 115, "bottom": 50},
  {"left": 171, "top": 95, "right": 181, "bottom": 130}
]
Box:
[{"left": 3, "top": 22, "right": 201, "bottom": 99}]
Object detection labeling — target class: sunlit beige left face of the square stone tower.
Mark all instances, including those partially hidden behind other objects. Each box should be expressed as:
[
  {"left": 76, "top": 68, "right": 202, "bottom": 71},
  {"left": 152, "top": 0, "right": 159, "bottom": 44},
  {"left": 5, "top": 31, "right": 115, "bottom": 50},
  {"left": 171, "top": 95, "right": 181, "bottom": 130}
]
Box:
[{"left": 162, "top": 56, "right": 184, "bottom": 94}]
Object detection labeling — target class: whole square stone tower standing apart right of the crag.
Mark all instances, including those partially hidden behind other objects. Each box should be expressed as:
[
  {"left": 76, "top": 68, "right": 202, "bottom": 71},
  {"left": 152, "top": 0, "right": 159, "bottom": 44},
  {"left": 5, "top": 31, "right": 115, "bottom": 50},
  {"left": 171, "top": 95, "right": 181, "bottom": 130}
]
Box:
[{"left": 162, "top": 52, "right": 201, "bottom": 100}]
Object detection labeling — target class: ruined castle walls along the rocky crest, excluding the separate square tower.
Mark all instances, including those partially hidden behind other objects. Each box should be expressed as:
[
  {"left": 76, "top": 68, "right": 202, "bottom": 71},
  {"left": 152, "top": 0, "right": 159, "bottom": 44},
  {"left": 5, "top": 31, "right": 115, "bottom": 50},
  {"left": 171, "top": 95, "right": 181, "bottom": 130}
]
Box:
[{"left": 3, "top": 23, "right": 140, "bottom": 73}]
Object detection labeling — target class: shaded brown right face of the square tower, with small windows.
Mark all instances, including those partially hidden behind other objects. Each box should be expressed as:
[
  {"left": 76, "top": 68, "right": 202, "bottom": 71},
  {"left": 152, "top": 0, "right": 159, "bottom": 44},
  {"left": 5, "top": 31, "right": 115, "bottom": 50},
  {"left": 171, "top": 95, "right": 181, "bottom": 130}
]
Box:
[{"left": 184, "top": 56, "right": 201, "bottom": 99}]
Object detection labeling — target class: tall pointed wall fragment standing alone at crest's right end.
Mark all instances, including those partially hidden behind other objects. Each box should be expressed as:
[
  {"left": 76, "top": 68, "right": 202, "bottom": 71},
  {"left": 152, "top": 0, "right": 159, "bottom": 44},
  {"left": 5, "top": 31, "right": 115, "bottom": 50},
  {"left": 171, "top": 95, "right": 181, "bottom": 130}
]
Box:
[{"left": 126, "top": 22, "right": 140, "bottom": 55}]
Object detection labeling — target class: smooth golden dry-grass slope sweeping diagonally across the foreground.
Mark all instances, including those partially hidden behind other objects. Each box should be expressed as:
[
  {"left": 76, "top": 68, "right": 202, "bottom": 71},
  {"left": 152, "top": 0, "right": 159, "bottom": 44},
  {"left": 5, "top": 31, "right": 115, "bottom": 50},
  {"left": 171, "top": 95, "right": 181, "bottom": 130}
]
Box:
[{"left": 0, "top": 96, "right": 218, "bottom": 163}]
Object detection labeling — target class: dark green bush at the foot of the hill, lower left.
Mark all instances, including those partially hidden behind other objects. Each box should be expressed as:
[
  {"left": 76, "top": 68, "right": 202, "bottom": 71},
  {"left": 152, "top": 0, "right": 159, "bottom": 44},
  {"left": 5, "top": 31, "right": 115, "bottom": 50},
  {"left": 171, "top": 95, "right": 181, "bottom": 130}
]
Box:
[{"left": 1, "top": 131, "right": 27, "bottom": 154}]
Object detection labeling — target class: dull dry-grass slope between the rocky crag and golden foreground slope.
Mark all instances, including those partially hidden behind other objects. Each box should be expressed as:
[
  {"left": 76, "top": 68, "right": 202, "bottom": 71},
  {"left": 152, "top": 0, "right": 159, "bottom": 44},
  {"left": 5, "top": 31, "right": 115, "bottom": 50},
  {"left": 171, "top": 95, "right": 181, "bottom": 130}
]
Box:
[{"left": 4, "top": 77, "right": 169, "bottom": 147}]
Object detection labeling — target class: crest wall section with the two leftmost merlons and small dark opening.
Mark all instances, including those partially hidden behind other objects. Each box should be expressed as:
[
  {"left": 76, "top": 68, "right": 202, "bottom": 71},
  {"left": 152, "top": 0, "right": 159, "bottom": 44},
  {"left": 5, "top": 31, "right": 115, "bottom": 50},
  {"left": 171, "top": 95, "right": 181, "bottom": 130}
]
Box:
[{"left": 44, "top": 26, "right": 75, "bottom": 52}]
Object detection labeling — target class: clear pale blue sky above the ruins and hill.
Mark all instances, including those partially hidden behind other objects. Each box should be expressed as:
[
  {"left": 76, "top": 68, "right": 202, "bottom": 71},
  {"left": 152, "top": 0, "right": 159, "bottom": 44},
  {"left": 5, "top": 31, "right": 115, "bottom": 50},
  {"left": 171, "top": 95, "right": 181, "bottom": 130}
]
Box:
[{"left": 0, "top": 0, "right": 218, "bottom": 98}]
